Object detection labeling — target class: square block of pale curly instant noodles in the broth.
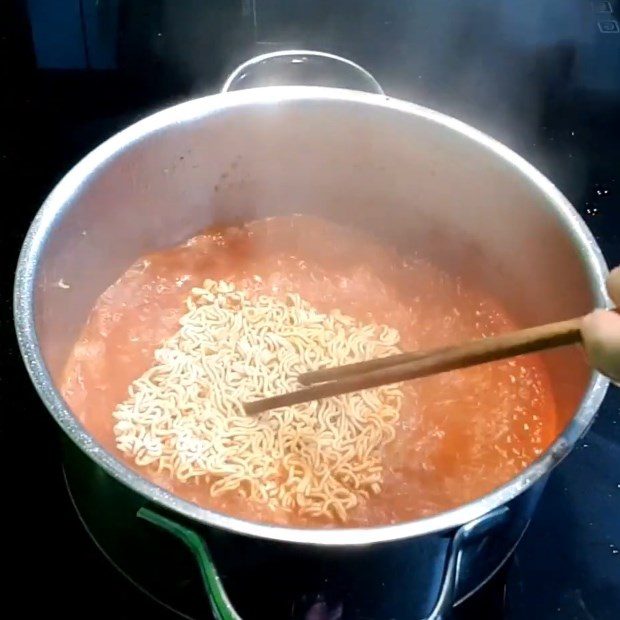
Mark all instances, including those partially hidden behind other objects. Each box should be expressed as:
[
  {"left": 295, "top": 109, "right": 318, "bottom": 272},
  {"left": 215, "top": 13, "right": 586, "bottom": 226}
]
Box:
[{"left": 114, "top": 280, "right": 403, "bottom": 522}]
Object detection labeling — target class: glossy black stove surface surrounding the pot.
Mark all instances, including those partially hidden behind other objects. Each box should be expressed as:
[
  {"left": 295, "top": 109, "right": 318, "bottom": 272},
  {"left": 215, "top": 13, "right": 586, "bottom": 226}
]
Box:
[{"left": 0, "top": 0, "right": 620, "bottom": 620}]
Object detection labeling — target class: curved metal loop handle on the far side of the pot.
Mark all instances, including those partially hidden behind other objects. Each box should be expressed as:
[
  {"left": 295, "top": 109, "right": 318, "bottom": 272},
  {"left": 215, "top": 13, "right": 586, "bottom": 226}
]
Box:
[{"left": 221, "top": 50, "right": 385, "bottom": 95}]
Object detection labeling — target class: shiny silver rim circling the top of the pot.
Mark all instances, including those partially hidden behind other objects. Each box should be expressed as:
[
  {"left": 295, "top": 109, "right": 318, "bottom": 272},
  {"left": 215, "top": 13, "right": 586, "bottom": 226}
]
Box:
[{"left": 14, "top": 86, "right": 609, "bottom": 546}]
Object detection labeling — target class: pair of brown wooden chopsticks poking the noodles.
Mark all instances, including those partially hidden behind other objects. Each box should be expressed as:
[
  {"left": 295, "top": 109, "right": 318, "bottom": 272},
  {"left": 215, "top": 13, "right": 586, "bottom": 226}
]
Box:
[{"left": 244, "top": 317, "right": 583, "bottom": 414}]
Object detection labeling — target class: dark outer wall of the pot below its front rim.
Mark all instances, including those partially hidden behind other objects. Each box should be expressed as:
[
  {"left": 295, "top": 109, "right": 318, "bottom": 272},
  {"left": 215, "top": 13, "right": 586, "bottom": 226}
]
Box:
[{"left": 65, "top": 442, "right": 544, "bottom": 620}]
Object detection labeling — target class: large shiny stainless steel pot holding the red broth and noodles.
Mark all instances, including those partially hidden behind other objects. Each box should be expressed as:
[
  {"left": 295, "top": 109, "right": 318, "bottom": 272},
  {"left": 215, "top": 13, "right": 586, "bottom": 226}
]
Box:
[{"left": 15, "top": 52, "right": 607, "bottom": 618}]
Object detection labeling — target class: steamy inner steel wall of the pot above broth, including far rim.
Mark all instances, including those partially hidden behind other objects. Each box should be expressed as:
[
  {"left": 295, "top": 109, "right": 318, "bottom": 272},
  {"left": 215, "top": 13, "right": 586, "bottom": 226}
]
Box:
[{"left": 17, "top": 87, "right": 604, "bottom": 544}]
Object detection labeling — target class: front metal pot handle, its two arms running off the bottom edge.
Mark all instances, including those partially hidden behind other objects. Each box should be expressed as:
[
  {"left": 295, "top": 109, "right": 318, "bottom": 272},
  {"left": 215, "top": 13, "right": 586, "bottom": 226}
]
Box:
[{"left": 138, "top": 506, "right": 509, "bottom": 620}]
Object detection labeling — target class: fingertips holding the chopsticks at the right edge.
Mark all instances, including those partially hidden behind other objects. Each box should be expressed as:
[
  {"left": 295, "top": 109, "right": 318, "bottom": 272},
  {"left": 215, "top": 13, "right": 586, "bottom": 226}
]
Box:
[{"left": 581, "top": 306, "right": 620, "bottom": 382}]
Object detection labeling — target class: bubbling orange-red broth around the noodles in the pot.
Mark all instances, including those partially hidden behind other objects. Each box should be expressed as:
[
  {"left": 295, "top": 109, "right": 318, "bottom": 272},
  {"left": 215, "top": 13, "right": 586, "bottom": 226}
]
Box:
[{"left": 62, "top": 216, "right": 556, "bottom": 526}]
